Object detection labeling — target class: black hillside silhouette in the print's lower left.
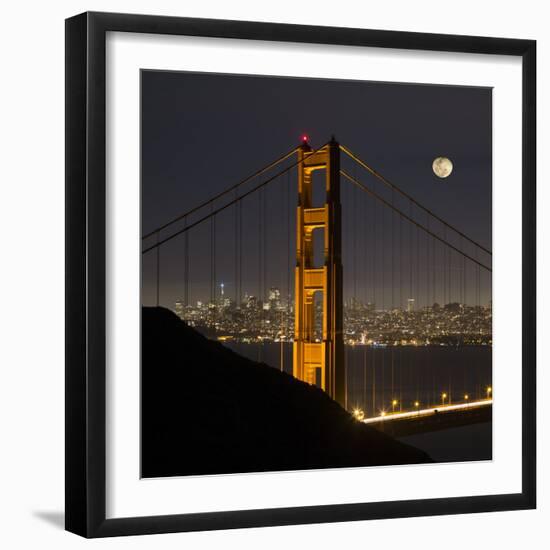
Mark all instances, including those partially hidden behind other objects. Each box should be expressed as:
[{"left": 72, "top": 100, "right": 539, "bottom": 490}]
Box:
[{"left": 142, "top": 308, "right": 431, "bottom": 477}]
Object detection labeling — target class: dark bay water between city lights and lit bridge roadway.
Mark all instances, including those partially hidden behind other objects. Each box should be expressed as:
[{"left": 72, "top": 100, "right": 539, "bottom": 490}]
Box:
[{"left": 224, "top": 342, "right": 492, "bottom": 416}]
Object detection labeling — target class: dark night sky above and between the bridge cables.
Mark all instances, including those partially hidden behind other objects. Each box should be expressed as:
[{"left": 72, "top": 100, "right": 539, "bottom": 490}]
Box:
[{"left": 142, "top": 71, "right": 492, "bottom": 306}]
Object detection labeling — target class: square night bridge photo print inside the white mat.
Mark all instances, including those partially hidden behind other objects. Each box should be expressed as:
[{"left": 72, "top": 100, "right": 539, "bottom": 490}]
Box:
[{"left": 140, "top": 70, "right": 494, "bottom": 478}]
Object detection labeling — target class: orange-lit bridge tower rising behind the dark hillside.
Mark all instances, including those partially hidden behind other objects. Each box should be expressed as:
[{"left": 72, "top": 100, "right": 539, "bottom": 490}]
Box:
[{"left": 293, "top": 138, "right": 345, "bottom": 406}]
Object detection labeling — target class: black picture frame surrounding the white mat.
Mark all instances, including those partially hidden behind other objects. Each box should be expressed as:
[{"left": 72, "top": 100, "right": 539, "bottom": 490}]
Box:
[{"left": 65, "top": 12, "right": 536, "bottom": 537}]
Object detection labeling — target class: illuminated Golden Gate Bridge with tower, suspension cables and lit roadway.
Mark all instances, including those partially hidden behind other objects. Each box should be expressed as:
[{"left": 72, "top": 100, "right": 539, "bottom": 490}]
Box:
[{"left": 142, "top": 136, "right": 492, "bottom": 421}]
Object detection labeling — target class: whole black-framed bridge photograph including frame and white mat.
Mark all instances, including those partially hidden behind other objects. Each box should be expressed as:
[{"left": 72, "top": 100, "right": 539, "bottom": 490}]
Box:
[{"left": 66, "top": 13, "right": 536, "bottom": 537}]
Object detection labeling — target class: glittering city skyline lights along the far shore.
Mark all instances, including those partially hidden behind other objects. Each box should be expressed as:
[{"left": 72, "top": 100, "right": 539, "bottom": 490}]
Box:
[{"left": 174, "top": 296, "right": 492, "bottom": 348}]
